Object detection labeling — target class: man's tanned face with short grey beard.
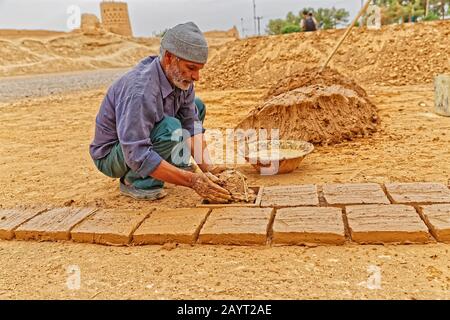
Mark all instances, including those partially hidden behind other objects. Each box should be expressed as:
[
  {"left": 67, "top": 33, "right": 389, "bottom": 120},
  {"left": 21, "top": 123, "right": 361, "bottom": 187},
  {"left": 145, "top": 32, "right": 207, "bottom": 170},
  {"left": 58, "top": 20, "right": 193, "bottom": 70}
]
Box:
[{"left": 167, "top": 53, "right": 205, "bottom": 90}]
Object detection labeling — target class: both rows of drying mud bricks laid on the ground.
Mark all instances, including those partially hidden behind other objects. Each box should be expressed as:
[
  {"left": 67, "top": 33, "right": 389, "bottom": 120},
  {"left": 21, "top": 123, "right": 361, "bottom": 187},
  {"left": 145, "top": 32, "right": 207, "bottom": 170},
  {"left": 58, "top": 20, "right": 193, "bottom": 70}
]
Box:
[{"left": 0, "top": 183, "right": 450, "bottom": 245}]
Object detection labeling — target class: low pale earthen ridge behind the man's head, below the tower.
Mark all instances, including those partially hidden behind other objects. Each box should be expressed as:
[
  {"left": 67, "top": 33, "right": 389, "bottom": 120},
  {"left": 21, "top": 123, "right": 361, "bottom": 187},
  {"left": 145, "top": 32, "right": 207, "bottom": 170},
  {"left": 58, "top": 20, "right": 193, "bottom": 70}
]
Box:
[{"left": 0, "top": 28, "right": 235, "bottom": 77}]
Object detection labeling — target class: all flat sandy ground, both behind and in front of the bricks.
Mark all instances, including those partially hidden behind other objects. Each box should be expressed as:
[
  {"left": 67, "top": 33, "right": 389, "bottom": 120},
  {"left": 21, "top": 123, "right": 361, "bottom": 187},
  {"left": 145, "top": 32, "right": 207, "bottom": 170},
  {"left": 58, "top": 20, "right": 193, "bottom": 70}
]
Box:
[{"left": 0, "top": 72, "right": 450, "bottom": 299}]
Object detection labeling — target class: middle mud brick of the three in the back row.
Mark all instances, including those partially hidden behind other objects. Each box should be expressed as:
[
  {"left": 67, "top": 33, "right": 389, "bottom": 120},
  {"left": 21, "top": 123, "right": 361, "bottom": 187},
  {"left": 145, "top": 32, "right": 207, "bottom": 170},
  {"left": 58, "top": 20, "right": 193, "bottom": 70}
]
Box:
[{"left": 323, "top": 183, "right": 390, "bottom": 205}]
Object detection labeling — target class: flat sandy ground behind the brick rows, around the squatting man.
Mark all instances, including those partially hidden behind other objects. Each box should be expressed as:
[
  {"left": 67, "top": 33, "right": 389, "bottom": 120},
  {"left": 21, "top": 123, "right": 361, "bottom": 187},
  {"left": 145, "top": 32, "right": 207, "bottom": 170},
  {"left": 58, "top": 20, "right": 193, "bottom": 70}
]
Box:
[{"left": 0, "top": 81, "right": 450, "bottom": 208}]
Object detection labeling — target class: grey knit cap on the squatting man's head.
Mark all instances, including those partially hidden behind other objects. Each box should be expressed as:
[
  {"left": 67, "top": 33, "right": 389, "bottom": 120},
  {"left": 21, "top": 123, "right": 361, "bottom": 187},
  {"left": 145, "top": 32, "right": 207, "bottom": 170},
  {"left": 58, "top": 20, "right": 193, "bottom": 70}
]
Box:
[{"left": 161, "top": 22, "right": 208, "bottom": 64}]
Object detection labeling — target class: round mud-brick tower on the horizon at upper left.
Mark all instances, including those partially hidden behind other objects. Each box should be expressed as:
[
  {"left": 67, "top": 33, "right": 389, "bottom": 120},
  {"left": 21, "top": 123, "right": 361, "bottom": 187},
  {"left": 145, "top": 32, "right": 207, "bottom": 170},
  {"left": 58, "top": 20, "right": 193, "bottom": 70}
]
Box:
[{"left": 100, "top": 1, "right": 133, "bottom": 37}]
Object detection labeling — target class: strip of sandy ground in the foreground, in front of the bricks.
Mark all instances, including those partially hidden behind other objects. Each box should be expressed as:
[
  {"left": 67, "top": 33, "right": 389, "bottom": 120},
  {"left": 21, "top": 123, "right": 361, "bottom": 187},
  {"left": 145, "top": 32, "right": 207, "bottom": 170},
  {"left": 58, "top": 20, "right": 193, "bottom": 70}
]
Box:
[{"left": 0, "top": 241, "right": 450, "bottom": 299}]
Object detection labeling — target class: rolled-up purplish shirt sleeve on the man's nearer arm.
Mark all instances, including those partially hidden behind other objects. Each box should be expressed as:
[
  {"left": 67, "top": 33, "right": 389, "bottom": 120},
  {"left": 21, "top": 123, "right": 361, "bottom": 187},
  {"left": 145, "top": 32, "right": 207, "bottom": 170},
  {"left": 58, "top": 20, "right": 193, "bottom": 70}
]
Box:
[{"left": 116, "top": 94, "right": 163, "bottom": 178}]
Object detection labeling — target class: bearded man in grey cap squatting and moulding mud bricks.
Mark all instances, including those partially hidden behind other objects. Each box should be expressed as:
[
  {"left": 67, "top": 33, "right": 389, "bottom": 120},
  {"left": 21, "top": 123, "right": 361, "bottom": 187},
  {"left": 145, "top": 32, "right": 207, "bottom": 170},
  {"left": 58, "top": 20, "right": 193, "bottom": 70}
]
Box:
[{"left": 90, "top": 22, "right": 231, "bottom": 202}]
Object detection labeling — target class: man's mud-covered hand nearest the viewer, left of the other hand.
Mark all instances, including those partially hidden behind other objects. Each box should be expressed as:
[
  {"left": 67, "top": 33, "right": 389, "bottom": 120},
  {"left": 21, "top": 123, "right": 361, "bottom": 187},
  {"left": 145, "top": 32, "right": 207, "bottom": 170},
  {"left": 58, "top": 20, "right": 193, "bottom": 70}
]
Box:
[{"left": 191, "top": 173, "right": 231, "bottom": 203}]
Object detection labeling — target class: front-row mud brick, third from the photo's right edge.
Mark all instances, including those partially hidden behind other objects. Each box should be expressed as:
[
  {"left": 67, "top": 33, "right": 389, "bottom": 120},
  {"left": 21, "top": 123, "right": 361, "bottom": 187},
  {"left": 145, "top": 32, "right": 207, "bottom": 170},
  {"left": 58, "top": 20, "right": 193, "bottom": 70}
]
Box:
[{"left": 272, "top": 207, "right": 345, "bottom": 245}]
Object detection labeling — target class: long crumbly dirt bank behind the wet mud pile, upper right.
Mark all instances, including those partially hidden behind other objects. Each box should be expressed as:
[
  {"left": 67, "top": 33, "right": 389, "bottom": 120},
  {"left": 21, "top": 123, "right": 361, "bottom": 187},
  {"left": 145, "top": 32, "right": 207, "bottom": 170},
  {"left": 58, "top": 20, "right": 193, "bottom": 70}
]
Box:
[{"left": 199, "top": 21, "right": 450, "bottom": 89}]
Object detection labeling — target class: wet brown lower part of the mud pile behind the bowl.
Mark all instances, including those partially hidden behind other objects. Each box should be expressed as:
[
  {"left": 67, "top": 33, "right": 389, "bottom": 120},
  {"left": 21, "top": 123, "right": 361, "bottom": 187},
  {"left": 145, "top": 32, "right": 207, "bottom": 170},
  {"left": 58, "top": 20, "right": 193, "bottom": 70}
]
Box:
[{"left": 237, "top": 84, "right": 379, "bottom": 144}]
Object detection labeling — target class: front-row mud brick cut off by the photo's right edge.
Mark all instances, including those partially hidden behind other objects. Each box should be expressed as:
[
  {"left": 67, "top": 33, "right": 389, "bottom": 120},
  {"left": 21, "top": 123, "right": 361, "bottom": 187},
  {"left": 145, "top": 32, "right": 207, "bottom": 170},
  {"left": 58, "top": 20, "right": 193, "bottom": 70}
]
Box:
[{"left": 421, "top": 204, "right": 450, "bottom": 243}]
